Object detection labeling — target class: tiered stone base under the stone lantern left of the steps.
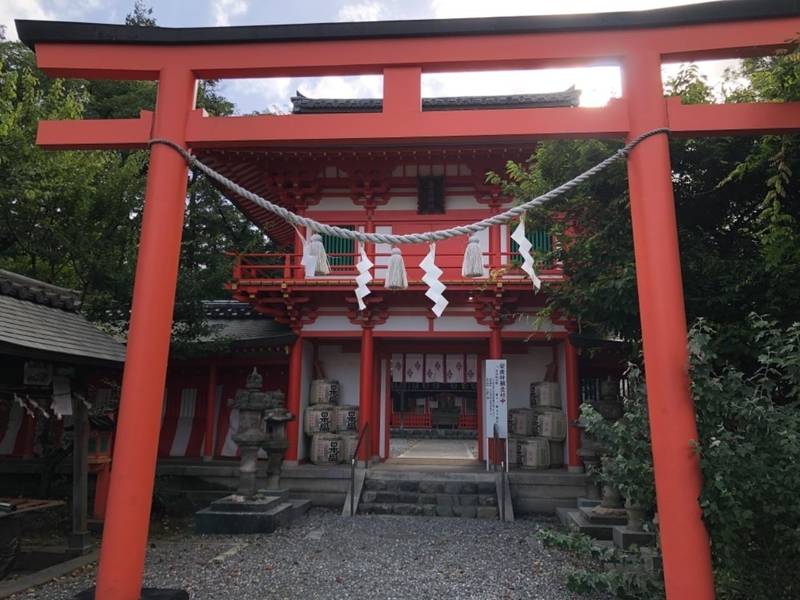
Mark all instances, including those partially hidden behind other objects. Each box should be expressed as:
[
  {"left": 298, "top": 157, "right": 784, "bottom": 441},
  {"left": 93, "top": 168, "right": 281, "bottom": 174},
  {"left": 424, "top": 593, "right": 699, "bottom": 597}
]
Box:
[{"left": 194, "top": 490, "right": 311, "bottom": 534}]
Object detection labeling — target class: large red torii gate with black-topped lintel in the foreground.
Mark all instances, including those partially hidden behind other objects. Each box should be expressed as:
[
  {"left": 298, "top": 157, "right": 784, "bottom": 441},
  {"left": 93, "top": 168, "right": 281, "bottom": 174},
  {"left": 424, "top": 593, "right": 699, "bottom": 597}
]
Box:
[{"left": 10, "top": 0, "right": 800, "bottom": 600}]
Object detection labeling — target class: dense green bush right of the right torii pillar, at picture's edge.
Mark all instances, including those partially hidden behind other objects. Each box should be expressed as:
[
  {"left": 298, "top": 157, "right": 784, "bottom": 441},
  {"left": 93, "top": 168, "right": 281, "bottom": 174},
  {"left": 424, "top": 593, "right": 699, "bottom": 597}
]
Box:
[{"left": 689, "top": 316, "right": 800, "bottom": 600}]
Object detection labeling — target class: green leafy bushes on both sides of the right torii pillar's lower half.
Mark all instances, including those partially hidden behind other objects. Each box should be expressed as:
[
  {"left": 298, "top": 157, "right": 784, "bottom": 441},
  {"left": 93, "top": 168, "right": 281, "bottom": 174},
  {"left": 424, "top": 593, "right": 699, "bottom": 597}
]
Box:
[{"left": 562, "top": 315, "right": 800, "bottom": 600}]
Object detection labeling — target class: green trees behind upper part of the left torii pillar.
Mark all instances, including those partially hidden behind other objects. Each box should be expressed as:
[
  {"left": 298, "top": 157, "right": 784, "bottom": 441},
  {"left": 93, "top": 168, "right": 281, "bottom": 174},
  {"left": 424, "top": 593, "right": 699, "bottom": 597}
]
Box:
[{"left": 0, "top": 1, "right": 266, "bottom": 338}]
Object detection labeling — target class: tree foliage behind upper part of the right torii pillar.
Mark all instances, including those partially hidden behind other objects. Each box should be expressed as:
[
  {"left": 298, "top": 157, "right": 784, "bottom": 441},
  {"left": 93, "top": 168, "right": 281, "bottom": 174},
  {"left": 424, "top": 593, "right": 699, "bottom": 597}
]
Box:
[{"left": 490, "top": 53, "right": 800, "bottom": 355}]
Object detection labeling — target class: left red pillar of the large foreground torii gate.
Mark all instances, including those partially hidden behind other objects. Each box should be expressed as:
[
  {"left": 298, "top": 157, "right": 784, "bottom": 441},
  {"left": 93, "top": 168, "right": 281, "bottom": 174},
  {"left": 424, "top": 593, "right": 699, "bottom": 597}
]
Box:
[{"left": 96, "top": 67, "right": 197, "bottom": 600}]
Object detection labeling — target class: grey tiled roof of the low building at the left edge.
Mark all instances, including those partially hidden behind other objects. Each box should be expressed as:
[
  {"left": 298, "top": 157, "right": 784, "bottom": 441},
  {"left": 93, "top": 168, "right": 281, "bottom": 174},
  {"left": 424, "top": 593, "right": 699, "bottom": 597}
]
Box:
[{"left": 0, "top": 270, "right": 125, "bottom": 362}]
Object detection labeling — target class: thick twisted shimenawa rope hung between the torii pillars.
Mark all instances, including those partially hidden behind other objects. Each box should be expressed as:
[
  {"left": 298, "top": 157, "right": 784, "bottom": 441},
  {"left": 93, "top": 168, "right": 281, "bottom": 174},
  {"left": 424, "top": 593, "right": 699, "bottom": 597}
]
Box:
[{"left": 148, "top": 127, "right": 669, "bottom": 244}]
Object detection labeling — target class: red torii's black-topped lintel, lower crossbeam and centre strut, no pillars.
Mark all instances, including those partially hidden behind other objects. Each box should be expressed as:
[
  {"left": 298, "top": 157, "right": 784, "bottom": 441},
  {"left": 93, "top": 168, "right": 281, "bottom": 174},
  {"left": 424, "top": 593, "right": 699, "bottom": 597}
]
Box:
[{"left": 17, "top": 0, "right": 800, "bottom": 148}]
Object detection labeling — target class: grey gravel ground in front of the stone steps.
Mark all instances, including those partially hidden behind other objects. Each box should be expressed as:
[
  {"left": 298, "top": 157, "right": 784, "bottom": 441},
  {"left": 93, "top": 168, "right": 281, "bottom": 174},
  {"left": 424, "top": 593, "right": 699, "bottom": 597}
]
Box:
[{"left": 13, "top": 509, "right": 585, "bottom": 600}]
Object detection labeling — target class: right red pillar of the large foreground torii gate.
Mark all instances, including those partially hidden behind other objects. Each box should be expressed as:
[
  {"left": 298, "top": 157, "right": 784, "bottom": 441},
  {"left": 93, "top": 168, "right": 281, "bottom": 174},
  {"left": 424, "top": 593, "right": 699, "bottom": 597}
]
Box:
[{"left": 624, "top": 50, "right": 714, "bottom": 600}]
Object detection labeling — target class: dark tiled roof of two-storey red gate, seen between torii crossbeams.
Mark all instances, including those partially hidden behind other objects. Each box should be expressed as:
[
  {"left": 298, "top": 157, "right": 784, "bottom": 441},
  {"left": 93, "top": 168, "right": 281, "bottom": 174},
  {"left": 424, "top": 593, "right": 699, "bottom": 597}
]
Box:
[{"left": 292, "top": 87, "right": 581, "bottom": 114}]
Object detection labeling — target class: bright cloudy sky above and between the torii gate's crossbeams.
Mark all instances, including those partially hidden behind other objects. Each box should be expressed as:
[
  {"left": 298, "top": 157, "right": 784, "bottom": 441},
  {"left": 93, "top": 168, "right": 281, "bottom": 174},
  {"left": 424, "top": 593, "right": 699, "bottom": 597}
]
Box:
[{"left": 0, "top": 0, "right": 731, "bottom": 113}]
